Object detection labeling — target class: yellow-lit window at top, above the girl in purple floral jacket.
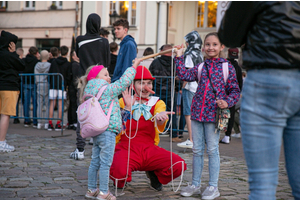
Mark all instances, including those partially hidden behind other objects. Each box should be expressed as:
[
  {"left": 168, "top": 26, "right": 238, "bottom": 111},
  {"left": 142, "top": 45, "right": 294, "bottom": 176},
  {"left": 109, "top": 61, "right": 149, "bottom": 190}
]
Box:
[{"left": 197, "top": 1, "right": 218, "bottom": 28}]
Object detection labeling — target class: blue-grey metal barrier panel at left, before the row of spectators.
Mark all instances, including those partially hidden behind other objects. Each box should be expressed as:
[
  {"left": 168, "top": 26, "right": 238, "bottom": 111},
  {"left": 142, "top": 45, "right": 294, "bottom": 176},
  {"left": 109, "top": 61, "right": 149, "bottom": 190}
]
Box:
[{"left": 12, "top": 73, "right": 69, "bottom": 137}]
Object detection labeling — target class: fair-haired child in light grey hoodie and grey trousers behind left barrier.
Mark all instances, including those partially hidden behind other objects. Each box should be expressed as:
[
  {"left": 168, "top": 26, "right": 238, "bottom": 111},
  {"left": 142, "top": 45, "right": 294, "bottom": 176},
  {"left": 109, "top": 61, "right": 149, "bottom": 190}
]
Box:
[{"left": 34, "top": 50, "right": 51, "bottom": 129}]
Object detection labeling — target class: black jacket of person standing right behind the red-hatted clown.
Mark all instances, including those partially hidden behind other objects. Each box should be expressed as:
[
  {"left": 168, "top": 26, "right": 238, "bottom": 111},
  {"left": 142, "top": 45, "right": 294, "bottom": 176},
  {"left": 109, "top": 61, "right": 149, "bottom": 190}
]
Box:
[{"left": 149, "top": 55, "right": 178, "bottom": 96}]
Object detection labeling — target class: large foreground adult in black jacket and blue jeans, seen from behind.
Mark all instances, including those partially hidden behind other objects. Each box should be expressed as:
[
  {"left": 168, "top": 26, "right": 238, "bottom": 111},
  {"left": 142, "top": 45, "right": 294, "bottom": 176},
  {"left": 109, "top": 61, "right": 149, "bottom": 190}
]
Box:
[{"left": 219, "top": 1, "right": 300, "bottom": 200}]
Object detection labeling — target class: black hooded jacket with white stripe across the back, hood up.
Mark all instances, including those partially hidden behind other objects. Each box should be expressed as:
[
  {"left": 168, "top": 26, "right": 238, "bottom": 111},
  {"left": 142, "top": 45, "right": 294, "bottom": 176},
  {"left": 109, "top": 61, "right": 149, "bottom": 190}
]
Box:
[{"left": 75, "top": 13, "right": 110, "bottom": 76}]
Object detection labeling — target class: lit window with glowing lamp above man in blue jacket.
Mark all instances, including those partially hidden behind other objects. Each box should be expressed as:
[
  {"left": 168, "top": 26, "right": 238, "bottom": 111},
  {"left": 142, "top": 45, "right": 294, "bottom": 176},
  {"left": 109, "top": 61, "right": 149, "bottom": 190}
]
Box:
[{"left": 109, "top": 1, "right": 136, "bottom": 25}]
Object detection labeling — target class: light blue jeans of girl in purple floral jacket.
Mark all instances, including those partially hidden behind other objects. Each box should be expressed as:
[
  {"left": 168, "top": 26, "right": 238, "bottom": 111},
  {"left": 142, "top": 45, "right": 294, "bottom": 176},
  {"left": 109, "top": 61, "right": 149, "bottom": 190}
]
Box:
[{"left": 192, "top": 120, "right": 220, "bottom": 187}]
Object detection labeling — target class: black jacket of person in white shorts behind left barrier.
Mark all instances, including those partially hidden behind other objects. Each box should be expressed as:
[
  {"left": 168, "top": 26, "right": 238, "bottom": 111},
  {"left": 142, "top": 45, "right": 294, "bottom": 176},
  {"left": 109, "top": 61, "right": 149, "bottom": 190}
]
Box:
[{"left": 49, "top": 56, "right": 71, "bottom": 90}]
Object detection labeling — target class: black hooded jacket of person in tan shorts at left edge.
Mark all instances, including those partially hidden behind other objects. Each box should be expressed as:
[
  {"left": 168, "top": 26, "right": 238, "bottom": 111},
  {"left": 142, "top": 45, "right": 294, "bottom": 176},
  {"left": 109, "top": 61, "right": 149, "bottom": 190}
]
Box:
[{"left": 0, "top": 31, "right": 25, "bottom": 91}]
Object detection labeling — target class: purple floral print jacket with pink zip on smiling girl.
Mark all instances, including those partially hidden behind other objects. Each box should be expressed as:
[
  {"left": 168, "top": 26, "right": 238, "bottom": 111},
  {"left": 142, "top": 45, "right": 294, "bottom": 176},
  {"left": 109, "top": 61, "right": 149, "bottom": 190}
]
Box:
[{"left": 174, "top": 56, "right": 240, "bottom": 122}]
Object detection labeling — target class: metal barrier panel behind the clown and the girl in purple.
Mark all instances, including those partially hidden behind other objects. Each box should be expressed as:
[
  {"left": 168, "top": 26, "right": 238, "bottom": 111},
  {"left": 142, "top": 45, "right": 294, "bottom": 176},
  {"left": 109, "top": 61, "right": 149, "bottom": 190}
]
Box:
[{"left": 153, "top": 76, "right": 187, "bottom": 133}]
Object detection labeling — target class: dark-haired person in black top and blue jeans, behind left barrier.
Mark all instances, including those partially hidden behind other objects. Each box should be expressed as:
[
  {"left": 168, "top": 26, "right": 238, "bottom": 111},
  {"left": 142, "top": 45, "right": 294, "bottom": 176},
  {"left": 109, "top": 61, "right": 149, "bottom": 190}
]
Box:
[{"left": 22, "top": 46, "right": 40, "bottom": 128}]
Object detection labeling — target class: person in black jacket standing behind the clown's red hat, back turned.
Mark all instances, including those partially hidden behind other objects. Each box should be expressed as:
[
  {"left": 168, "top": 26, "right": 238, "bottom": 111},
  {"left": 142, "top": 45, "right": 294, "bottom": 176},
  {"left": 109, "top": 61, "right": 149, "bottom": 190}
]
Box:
[{"left": 149, "top": 44, "right": 181, "bottom": 142}]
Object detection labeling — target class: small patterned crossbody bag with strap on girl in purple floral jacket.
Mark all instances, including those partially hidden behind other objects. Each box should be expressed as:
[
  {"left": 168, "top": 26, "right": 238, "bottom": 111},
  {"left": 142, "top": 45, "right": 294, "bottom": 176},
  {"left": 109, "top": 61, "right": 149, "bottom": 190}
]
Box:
[{"left": 206, "top": 62, "right": 230, "bottom": 132}]
